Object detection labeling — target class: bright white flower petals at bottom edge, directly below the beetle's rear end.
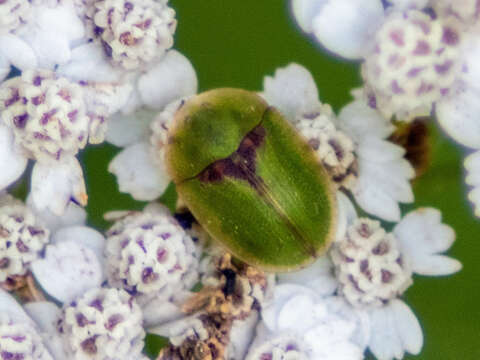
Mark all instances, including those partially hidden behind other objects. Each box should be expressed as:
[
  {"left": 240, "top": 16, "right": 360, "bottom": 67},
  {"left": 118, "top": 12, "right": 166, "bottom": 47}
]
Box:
[{"left": 246, "top": 284, "right": 369, "bottom": 360}]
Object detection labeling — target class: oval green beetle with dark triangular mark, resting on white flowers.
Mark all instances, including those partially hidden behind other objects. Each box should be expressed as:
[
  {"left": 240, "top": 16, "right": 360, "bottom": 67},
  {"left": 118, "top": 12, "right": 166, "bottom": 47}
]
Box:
[{"left": 165, "top": 89, "right": 336, "bottom": 272}]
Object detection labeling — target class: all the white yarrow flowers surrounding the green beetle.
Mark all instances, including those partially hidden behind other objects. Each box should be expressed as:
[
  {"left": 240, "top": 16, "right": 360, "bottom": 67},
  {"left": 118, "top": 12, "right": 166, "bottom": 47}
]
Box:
[{"left": 0, "top": 0, "right": 466, "bottom": 360}]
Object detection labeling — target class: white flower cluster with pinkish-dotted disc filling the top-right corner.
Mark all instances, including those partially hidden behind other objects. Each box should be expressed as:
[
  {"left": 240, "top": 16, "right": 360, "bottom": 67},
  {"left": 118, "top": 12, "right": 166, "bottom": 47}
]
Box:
[{"left": 292, "top": 0, "right": 480, "bottom": 216}]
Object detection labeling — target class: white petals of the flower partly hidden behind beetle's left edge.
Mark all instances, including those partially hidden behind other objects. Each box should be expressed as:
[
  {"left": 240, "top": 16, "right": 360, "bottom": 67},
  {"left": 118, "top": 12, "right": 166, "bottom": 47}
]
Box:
[{"left": 107, "top": 50, "right": 197, "bottom": 201}]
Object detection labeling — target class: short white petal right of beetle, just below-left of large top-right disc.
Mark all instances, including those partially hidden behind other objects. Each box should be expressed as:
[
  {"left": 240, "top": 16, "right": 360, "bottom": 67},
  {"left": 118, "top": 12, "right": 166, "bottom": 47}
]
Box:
[{"left": 338, "top": 100, "right": 395, "bottom": 142}]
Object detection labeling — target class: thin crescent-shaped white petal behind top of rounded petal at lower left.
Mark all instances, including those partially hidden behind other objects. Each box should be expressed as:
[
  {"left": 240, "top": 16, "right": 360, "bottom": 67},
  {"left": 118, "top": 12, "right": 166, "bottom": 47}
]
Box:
[{"left": 51, "top": 226, "right": 105, "bottom": 264}]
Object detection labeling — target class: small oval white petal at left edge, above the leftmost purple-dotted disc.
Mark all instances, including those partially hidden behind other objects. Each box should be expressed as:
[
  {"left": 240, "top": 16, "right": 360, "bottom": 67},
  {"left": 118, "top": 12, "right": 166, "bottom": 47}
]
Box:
[{"left": 0, "top": 34, "right": 37, "bottom": 71}]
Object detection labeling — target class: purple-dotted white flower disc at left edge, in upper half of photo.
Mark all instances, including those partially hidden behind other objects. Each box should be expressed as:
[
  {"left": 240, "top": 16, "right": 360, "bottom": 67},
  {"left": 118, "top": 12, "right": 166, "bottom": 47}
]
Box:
[{"left": 0, "top": 70, "right": 89, "bottom": 162}]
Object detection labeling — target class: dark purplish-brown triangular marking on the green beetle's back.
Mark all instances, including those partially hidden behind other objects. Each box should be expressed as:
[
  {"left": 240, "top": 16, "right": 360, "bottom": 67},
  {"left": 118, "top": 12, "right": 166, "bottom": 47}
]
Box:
[{"left": 198, "top": 125, "right": 266, "bottom": 190}]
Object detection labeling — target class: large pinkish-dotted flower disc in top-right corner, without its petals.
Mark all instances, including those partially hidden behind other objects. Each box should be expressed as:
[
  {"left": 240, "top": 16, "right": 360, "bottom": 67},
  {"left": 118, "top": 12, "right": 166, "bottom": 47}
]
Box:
[{"left": 362, "top": 10, "right": 461, "bottom": 121}]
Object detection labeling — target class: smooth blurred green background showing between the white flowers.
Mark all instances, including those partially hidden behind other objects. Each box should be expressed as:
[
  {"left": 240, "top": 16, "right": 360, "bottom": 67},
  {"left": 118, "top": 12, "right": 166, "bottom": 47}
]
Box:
[{"left": 78, "top": 0, "right": 480, "bottom": 360}]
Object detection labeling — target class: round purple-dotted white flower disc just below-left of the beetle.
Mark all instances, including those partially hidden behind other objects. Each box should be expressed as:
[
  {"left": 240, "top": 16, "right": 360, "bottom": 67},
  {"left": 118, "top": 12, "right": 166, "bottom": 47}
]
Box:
[{"left": 105, "top": 211, "right": 198, "bottom": 299}]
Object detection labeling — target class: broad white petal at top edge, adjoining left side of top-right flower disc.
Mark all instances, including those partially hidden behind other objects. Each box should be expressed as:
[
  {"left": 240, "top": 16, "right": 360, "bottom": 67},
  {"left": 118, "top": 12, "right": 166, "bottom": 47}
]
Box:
[{"left": 313, "top": 0, "right": 384, "bottom": 59}]
